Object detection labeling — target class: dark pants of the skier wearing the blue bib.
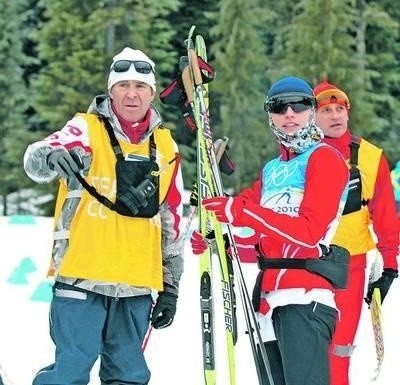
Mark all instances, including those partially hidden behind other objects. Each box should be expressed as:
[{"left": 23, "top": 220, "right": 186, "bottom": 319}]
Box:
[{"left": 260, "top": 302, "right": 337, "bottom": 385}]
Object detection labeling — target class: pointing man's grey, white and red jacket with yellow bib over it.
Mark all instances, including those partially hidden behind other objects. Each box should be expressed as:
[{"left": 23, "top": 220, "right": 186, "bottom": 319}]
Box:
[{"left": 24, "top": 96, "right": 183, "bottom": 297}]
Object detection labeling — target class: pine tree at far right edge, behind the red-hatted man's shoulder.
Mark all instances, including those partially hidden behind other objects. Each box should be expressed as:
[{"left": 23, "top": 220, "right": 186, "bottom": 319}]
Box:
[{"left": 358, "top": 1, "right": 400, "bottom": 167}]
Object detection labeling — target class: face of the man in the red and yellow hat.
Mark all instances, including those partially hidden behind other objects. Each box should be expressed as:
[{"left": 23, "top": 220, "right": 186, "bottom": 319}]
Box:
[{"left": 315, "top": 103, "right": 349, "bottom": 138}]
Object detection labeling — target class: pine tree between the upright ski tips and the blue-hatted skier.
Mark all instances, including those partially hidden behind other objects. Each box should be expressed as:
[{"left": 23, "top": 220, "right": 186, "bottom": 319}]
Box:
[{"left": 210, "top": 0, "right": 276, "bottom": 191}]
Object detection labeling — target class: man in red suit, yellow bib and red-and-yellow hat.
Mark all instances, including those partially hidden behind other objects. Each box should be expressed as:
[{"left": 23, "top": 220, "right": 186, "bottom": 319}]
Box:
[{"left": 314, "top": 81, "right": 399, "bottom": 385}]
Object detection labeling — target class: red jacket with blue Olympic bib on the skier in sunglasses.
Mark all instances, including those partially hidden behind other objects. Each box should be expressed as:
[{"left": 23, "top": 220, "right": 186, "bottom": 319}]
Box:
[{"left": 235, "top": 144, "right": 348, "bottom": 314}]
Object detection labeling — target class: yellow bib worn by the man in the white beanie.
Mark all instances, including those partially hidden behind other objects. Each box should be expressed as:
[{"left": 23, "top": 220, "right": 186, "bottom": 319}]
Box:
[{"left": 55, "top": 114, "right": 176, "bottom": 290}]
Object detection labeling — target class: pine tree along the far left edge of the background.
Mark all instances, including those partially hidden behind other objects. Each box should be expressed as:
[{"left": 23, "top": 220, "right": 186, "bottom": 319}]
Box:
[{"left": 0, "top": 0, "right": 37, "bottom": 215}]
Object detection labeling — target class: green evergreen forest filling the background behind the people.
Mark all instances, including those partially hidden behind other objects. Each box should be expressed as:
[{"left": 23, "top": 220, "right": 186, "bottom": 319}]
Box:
[{"left": 0, "top": 0, "right": 400, "bottom": 215}]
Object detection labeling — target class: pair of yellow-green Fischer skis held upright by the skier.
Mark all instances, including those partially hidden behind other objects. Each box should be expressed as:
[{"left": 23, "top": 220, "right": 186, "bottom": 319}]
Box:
[{"left": 182, "top": 26, "right": 236, "bottom": 385}]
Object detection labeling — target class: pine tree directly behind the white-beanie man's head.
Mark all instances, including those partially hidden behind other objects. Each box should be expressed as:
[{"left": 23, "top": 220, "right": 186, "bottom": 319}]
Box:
[{"left": 33, "top": 0, "right": 177, "bottom": 130}]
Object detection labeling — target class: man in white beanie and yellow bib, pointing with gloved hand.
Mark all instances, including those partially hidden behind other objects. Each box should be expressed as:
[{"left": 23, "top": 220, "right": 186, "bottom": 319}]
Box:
[{"left": 24, "top": 47, "right": 183, "bottom": 385}]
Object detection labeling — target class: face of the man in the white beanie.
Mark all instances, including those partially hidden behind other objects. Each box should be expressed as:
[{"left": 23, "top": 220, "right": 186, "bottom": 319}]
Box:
[{"left": 109, "top": 80, "right": 155, "bottom": 122}]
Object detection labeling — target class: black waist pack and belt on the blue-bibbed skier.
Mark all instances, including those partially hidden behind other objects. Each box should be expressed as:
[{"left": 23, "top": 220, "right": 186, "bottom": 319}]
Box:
[{"left": 257, "top": 245, "right": 350, "bottom": 289}]
